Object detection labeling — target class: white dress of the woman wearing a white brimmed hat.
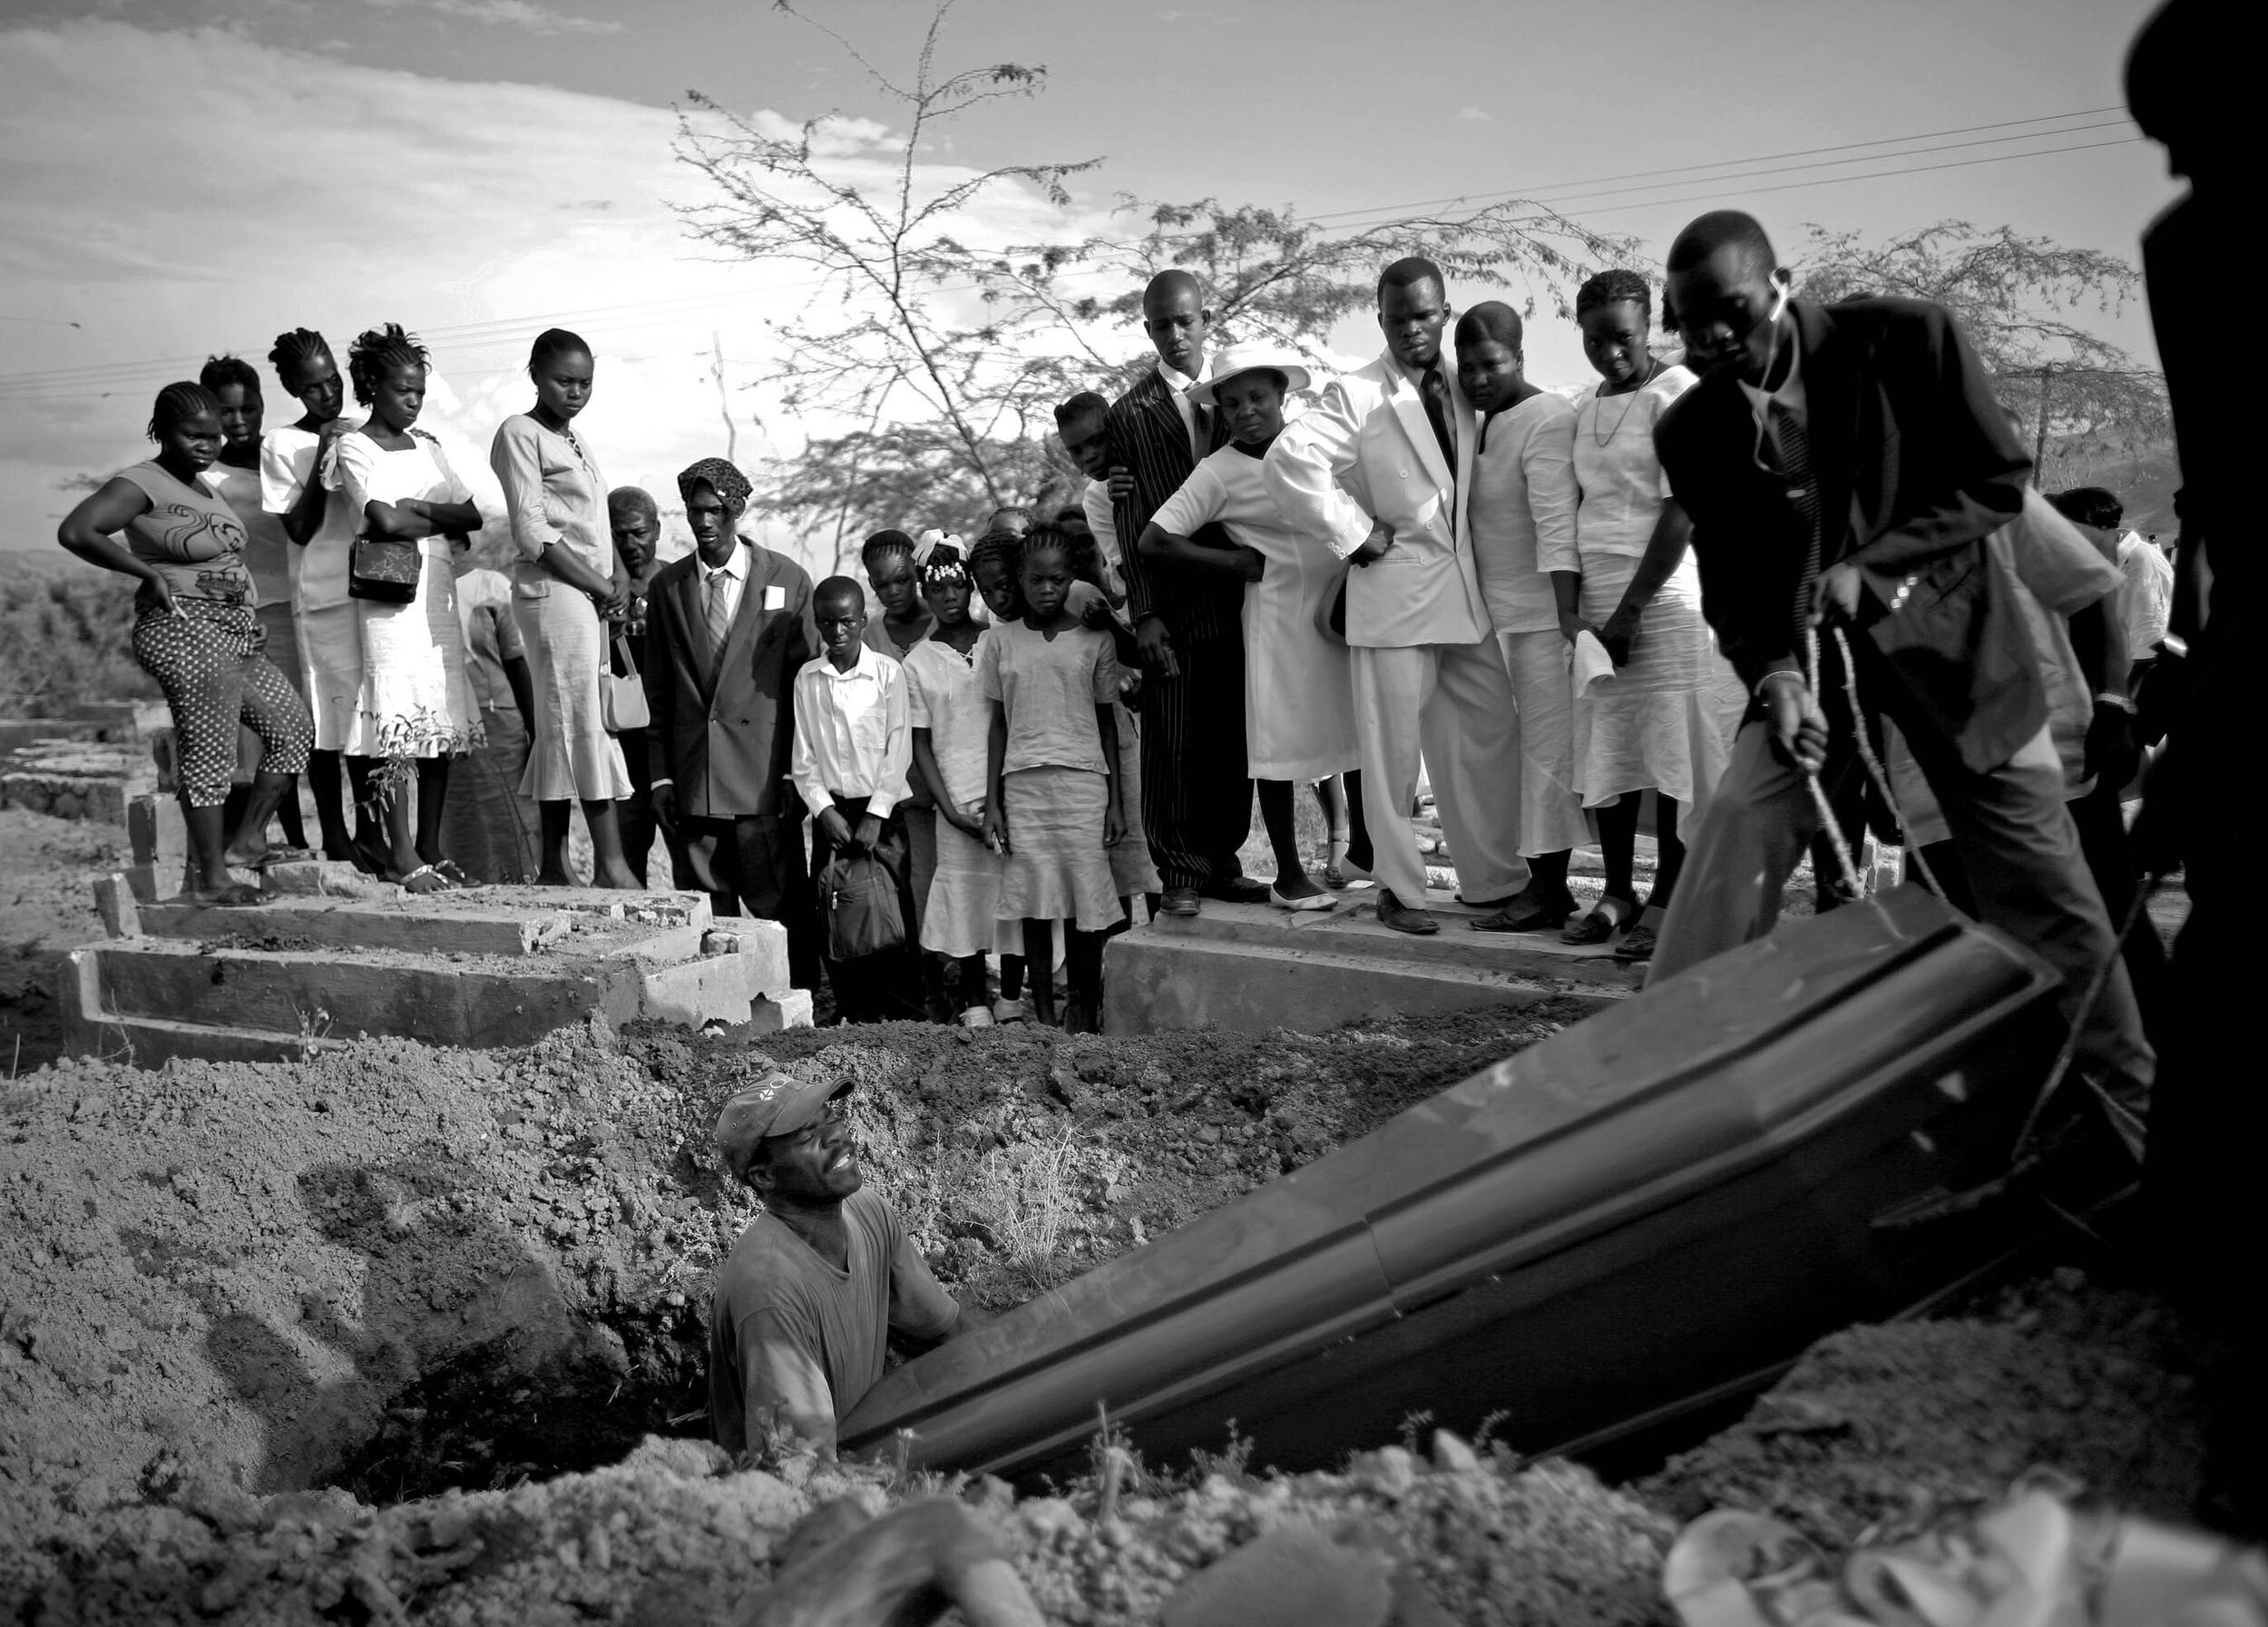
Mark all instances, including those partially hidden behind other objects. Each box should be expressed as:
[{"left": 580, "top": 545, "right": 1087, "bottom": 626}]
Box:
[{"left": 1150, "top": 445, "right": 1361, "bottom": 780}]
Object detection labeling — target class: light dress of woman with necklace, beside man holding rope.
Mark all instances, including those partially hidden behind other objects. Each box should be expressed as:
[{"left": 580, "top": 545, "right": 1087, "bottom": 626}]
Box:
[{"left": 1579, "top": 368, "right": 1737, "bottom": 808}]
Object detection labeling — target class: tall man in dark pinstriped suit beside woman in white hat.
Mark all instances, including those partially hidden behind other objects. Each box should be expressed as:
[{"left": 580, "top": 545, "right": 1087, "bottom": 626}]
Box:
[{"left": 1105, "top": 270, "right": 1268, "bottom": 915}]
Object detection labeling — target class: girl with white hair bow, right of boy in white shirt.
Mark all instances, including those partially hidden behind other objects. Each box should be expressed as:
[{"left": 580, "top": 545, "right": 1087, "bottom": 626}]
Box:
[{"left": 905, "top": 544, "right": 1001, "bottom": 1028}]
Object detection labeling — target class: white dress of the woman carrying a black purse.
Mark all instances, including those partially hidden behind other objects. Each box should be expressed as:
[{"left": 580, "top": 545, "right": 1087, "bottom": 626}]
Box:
[{"left": 334, "top": 429, "right": 485, "bottom": 758}]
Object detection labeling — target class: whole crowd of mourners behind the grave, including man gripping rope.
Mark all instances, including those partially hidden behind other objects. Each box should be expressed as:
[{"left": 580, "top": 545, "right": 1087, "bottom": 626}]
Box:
[{"left": 62, "top": 211, "right": 2173, "bottom": 1066}]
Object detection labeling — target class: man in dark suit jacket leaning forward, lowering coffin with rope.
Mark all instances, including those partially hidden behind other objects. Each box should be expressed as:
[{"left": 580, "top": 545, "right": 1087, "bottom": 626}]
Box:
[{"left": 1654, "top": 211, "right": 2155, "bottom": 1084}]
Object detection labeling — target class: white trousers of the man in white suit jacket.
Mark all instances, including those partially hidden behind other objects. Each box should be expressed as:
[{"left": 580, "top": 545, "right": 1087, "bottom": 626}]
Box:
[{"left": 1350, "top": 633, "right": 1529, "bottom": 910}]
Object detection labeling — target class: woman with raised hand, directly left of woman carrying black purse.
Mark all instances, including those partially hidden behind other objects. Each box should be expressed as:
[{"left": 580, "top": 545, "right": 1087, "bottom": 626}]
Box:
[{"left": 261, "top": 327, "right": 363, "bottom": 858}]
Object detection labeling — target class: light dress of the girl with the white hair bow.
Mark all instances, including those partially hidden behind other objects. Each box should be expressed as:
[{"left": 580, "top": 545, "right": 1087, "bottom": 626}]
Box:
[{"left": 905, "top": 631, "right": 1023, "bottom": 960}]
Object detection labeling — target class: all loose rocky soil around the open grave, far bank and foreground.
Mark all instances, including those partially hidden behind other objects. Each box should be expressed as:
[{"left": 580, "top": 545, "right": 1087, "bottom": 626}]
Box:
[{"left": 0, "top": 815, "right": 2232, "bottom": 1627}]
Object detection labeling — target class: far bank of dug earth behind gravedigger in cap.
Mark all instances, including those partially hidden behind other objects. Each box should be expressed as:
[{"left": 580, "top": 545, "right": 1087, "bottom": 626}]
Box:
[{"left": 0, "top": 1007, "right": 1577, "bottom": 1597}]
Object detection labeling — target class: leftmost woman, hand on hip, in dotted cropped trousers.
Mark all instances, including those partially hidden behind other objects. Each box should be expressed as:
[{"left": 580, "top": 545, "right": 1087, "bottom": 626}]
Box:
[{"left": 57, "top": 384, "right": 308, "bottom": 906}]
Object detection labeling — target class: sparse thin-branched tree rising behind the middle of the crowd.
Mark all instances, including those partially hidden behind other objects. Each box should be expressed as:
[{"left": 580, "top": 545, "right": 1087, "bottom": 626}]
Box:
[{"left": 679, "top": 0, "right": 1636, "bottom": 551}]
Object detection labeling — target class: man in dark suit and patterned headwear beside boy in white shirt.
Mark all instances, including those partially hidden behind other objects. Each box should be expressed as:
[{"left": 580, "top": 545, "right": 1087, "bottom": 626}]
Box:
[{"left": 647, "top": 458, "right": 819, "bottom": 989}]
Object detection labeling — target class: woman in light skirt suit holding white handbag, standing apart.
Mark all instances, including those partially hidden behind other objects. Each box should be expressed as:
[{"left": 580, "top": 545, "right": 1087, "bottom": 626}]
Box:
[{"left": 488, "top": 327, "right": 640, "bottom": 892}]
